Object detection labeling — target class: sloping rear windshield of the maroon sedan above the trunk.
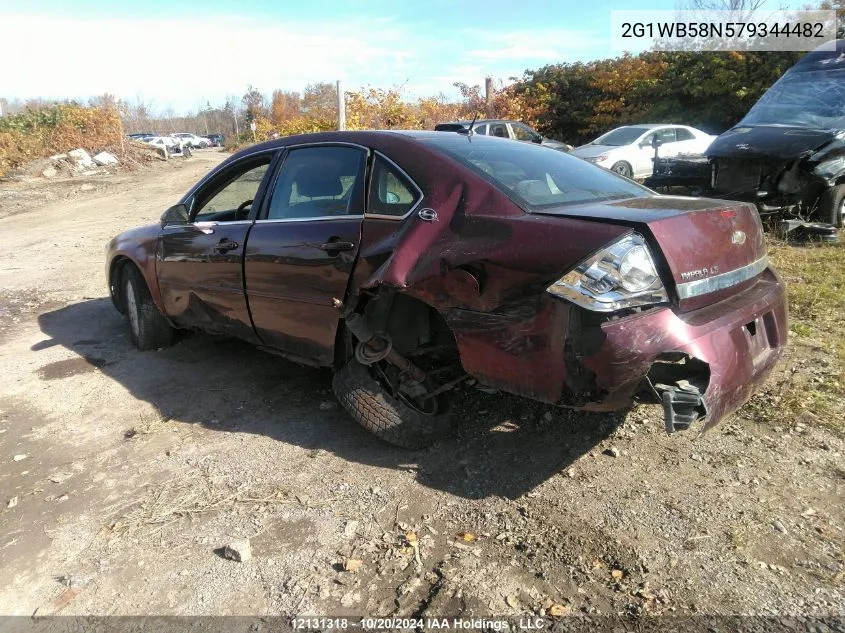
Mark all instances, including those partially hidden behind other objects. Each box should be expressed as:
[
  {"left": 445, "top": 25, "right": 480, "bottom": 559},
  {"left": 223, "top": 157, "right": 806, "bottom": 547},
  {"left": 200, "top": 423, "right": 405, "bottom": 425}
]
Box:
[{"left": 424, "top": 135, "right": 654, "bottom": 211}]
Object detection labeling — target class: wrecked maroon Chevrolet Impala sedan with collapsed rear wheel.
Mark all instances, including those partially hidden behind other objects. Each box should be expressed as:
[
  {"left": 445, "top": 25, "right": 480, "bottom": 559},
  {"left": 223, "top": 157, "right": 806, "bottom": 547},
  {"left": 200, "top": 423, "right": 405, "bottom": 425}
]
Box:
[{"left": 106, "top": 132, "right": 787, "bottom": 447}]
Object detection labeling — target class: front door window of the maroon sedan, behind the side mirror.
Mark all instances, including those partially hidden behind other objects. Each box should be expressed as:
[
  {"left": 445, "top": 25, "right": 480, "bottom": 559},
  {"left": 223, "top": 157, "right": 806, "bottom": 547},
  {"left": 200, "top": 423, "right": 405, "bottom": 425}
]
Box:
[{"left": 193, "top": 154, "right": 273, "bottom": 222}]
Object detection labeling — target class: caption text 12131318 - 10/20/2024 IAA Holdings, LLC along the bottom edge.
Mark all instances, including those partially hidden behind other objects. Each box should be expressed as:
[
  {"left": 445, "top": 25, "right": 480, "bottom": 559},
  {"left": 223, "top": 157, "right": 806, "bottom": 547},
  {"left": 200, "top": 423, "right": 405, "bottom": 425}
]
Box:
[{"left": 291, "top": 617, "right": 549, "bottom": 631}]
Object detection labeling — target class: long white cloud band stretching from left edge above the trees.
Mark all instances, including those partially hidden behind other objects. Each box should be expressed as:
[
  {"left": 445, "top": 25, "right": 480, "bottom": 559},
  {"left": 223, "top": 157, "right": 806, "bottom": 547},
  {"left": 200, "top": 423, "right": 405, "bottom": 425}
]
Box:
[{"left": 0, "top": 14, "right": 604, "bottom": 111}]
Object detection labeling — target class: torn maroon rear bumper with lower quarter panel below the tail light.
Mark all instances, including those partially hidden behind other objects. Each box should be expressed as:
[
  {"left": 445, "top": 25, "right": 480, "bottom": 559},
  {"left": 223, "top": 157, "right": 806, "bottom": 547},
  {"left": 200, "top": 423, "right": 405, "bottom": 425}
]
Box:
[{"left": 446, "top": 269, "right": 788, "bottom": 428}]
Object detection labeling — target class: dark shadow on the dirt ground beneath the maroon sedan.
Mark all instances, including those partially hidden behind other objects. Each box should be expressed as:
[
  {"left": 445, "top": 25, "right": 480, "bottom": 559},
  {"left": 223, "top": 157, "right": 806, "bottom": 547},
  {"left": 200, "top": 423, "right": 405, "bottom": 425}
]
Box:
[{"left": 31, "top": 298, "right": 626, "bottom": 499}]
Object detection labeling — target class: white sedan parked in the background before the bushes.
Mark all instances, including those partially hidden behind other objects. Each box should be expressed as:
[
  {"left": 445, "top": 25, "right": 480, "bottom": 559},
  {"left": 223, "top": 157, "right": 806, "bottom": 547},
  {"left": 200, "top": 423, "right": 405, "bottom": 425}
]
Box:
[{"left": 572, "top": 123, "right": 716, "bottom": 179}]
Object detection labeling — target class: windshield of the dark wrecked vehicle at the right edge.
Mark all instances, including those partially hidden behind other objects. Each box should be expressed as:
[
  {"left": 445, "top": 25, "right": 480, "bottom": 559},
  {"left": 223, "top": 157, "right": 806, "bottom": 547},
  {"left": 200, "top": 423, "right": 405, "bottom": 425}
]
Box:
[{"left": 739, "top": 69, "right": 845, "bottom": 130}]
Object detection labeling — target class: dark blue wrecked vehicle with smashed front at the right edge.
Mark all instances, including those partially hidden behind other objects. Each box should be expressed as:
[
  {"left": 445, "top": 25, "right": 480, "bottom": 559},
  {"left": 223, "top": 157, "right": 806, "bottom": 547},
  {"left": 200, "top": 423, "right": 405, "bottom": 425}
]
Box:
[{"left": 647, "top": 40, "right": 845, "bottom": 227}]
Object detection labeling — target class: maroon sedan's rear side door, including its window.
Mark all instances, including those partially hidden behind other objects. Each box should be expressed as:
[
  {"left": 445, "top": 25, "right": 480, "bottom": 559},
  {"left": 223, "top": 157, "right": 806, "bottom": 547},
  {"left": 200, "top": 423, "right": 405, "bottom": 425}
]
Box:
[{"left": 244, "top": 143, "right": 368, "bottom": 365}]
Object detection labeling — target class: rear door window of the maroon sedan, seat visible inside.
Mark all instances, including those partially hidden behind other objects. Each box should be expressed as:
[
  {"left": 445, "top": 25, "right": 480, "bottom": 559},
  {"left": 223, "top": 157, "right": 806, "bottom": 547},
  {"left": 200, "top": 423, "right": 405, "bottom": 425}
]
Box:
[{"left": 267, "top": 145, "right": 366, "bottom": 220}]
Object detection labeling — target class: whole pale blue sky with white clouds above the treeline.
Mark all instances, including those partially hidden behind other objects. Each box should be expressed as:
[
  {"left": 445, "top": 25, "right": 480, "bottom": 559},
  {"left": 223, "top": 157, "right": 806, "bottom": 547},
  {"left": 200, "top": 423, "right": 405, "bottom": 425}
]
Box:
[{"left": 0, "top": 0, "right": 796, "bottom": 113}]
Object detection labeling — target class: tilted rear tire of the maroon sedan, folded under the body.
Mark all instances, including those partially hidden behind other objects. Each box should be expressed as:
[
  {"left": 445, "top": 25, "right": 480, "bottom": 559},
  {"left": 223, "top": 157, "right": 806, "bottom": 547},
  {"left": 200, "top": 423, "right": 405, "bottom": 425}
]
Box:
[{"left": 332, "top": 360, "right": 452, "bottom": 448}]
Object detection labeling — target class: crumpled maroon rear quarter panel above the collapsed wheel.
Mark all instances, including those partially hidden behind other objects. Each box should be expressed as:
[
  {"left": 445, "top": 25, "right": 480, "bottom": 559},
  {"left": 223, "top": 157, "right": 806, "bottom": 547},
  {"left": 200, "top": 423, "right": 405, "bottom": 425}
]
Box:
[{"left": 342, "top": 135, "right": 630, "bottom": 402}]
